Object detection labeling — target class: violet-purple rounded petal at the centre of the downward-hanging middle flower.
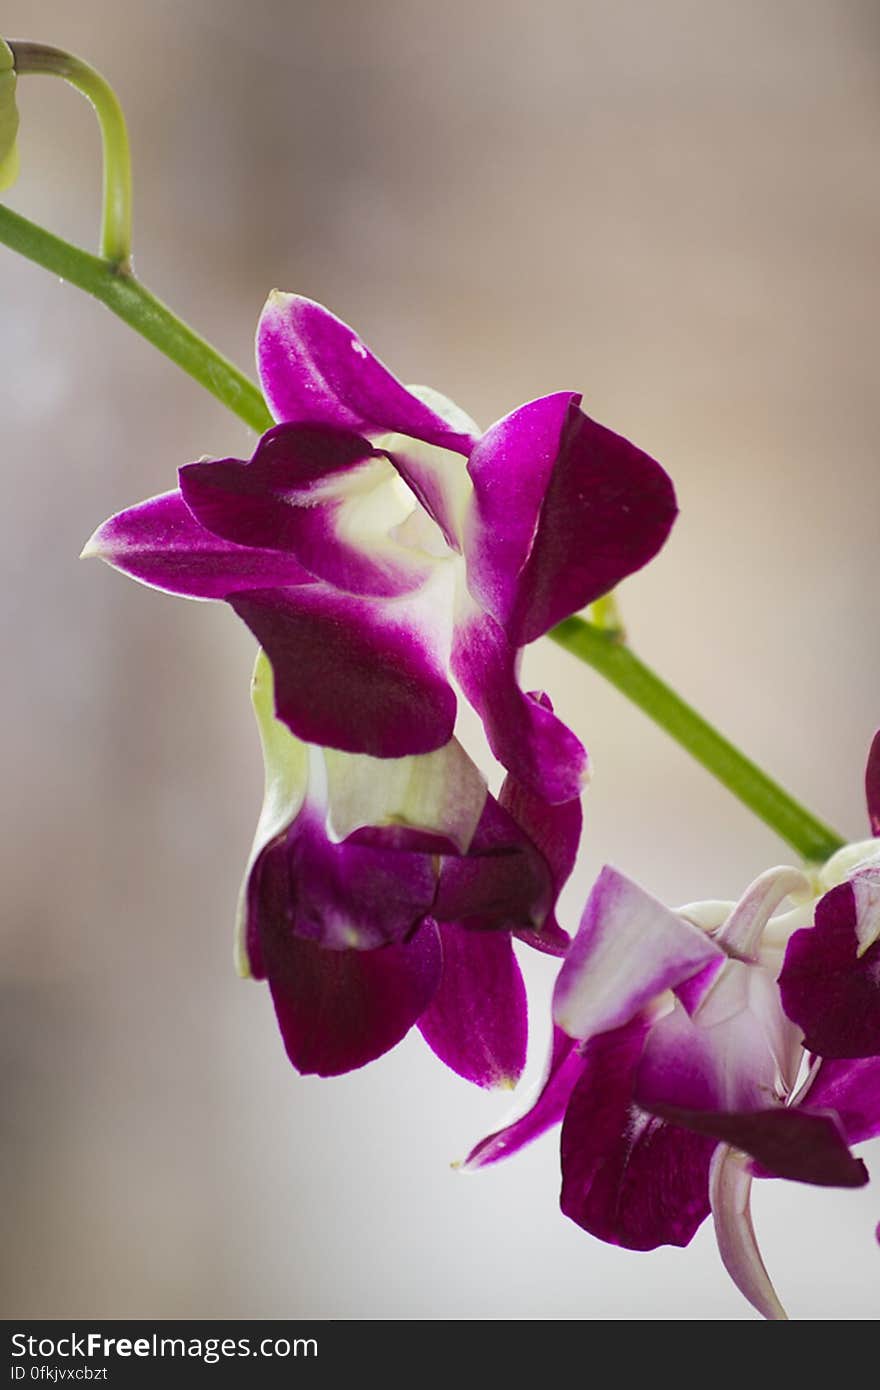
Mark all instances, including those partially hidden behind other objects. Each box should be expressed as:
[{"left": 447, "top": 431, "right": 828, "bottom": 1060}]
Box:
[{"left": 260, "top": 803, "right": 437, "bottom": 951}]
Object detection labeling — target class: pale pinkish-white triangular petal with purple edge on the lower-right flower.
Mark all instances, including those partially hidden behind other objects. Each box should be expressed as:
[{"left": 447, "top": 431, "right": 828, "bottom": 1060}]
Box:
[{"left": 553, "top": 866, "right": 726, "bottom": 1038}]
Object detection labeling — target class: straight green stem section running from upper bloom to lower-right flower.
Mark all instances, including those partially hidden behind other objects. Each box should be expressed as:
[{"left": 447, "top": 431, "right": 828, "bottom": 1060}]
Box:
[{"left": 549, "top": 617, "right": 844, "bottom": 862}]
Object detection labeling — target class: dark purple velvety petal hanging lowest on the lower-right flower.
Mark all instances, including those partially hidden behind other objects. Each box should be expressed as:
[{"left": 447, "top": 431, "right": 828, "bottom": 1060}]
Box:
[{"left": 562, "top": 1017, "right": 715, "bottom": 1250}]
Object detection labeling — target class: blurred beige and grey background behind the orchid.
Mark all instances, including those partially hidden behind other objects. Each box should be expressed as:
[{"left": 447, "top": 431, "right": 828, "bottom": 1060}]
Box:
[{"left": 0, "top": 0, "right": 880, "bottom": 1319}]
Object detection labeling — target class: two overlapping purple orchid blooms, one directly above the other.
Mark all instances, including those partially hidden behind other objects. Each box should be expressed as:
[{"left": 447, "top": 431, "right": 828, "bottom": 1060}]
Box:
[{"left": 83, "top": 293, "right": 676, "bottom": 1086}]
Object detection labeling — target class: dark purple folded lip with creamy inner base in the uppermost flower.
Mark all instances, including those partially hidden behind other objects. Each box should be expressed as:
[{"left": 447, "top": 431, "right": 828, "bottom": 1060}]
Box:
[{"left": 179, "top": 425, "right": 430, "bottom": 595}]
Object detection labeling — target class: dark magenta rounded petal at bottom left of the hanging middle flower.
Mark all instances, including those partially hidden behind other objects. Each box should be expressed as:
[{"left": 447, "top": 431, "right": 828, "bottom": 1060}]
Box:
[{"left": 263, "top": 922, "right": 442, "bottom": 1076}]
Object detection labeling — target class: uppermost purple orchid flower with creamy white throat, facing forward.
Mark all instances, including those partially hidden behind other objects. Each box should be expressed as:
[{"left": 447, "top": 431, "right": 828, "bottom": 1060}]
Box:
[{"left": 83, "top": 293, "right": 676, "bottom": 803}]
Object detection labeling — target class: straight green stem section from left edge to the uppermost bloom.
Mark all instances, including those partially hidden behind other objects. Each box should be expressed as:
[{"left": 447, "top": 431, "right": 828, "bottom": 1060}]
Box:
[{"left": 0, "top": 204, "right": 272, "bottom": 434}]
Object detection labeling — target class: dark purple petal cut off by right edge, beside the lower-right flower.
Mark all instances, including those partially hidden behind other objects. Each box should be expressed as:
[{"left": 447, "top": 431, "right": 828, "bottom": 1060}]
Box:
[{"left": 779, "top": 870, "right": 880, "bottom": 1058}]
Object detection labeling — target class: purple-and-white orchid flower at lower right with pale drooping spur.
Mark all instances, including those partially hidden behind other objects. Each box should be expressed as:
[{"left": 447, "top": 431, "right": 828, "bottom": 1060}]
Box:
[{"left": 467, "top": 850, "right": 880, "bottom": 1319}]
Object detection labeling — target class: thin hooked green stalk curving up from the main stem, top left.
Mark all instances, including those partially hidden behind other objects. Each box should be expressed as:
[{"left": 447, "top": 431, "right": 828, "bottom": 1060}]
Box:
[{"left": 8, "top": 39, "right": 132, "bottom": 271}]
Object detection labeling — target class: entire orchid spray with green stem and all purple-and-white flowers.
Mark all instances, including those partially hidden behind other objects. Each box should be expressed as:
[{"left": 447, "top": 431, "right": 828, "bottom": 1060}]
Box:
[{"left": 0, "top": 29, "right": 880, "bottom": 1318}]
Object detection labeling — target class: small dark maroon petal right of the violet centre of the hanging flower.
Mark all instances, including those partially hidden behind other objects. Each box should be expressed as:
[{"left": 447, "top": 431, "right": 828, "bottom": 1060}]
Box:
[{"left": 434, "top": 796, "right": 552, "bottom": 931}]
